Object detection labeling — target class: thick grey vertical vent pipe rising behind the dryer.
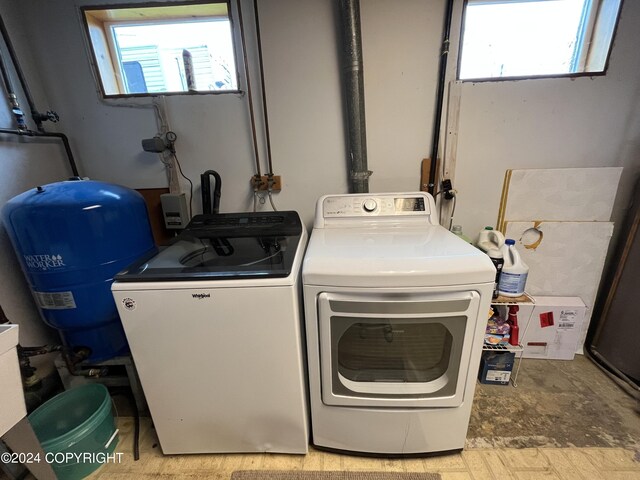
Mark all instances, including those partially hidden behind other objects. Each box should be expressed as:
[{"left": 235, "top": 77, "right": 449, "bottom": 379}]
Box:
[{"left": 339, "top": 0, "right": 372, "bottom": 193}]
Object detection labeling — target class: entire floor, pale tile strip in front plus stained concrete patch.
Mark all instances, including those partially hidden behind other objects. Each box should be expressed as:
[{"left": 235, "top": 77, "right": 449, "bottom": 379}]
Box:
[{"left": 90, "top": 356, "right": 640, "bottom": 480}]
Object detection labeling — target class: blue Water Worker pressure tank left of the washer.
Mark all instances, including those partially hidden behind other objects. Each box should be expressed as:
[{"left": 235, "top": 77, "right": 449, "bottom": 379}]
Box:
[{"left": 2, "top": 180, "right": 156, "bottom": 361}]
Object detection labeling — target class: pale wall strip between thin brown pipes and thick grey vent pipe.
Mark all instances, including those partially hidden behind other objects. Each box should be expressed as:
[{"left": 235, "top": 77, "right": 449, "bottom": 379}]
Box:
[{"left": 244, "top": 0, "right": 348, "bottom": 221}]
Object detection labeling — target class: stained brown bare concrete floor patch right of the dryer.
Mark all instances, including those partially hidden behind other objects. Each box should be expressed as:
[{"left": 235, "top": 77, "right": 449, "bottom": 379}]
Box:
[{"left": 467, "top": 355, "right": 640, "bottom": 449}]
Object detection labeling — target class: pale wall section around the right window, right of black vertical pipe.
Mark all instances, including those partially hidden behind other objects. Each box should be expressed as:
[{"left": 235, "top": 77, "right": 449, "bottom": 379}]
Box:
[{"left": 454, "top": 1, "right": 640, "bottom": 240}]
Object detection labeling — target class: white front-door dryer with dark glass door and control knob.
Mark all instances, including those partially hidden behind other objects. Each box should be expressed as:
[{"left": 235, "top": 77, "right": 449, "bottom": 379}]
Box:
[{"left": 302, "top": 192, "right": 495, "bottom": 455}]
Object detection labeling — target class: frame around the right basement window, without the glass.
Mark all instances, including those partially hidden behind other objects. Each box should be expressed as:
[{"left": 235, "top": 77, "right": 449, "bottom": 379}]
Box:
[{"left": 456, "top": 0, "right": 624, "bottom": 83}]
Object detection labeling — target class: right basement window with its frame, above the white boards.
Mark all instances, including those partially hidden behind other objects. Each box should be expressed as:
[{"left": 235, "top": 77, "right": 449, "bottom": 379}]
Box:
[{"left": 458, "top": 0, "right": 622, "bottom": 80}]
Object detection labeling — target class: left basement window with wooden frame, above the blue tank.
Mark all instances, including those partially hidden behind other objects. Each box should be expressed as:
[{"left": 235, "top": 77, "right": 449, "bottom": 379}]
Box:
[{"left": 81, "top": 2, "right": 238, "bottom": 97}]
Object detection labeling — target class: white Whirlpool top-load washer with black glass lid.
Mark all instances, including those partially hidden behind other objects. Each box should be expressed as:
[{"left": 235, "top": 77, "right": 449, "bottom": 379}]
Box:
[{"left": 112, "top": 212, "right": 309, "bottom": 454}]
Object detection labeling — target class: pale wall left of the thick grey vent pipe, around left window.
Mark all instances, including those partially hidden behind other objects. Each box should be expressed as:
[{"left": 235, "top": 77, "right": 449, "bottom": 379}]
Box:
[{"left": 17, "top": 0, "right": 348, "bottom": 229}]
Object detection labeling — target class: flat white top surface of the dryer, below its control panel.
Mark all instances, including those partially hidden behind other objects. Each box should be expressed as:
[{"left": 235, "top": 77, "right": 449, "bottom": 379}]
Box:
[{"left": 302, "top": 225, "right": 496, "bottom": 287}]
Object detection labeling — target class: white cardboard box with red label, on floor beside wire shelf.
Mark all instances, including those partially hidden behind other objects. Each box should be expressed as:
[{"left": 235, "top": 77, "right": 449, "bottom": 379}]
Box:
[{"left": 518, "top": 296, "right": 587, "bottom": 360}]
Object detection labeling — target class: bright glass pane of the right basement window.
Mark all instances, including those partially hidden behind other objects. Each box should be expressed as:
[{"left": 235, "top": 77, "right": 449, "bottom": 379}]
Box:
[{"left": 460, "top": 0, "right": 589, "bottom": 79}]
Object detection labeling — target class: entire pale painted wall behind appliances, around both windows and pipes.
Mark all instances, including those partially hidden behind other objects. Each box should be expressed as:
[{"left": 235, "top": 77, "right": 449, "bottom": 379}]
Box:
[{"left": 3, "top": 0, "right": 640, "bottom": 330}]
